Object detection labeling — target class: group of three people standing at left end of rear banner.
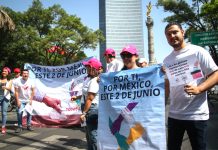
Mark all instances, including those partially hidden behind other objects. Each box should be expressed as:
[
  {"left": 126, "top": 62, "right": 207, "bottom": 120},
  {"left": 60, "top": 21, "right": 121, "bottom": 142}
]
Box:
[{"left": 0, "top": 67, "right": 34, "bottom": 134}]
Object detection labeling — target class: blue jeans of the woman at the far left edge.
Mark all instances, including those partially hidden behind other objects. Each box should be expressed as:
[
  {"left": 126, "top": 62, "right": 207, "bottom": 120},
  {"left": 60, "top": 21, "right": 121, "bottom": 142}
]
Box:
[{"left": 0, "top": 97, "right": 9, "bottom": 127}]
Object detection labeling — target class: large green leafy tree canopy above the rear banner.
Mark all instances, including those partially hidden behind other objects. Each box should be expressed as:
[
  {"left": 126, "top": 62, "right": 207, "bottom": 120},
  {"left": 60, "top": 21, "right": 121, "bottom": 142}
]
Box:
[{"left": 0, "top": 0, "right": 103, "bottom": 68}]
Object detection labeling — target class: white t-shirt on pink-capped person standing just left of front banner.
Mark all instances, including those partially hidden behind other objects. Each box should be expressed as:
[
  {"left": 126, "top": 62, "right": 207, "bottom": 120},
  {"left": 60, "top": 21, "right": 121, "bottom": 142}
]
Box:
[{"left": 82, "top": 77, "right": 99, "bottom": 105}]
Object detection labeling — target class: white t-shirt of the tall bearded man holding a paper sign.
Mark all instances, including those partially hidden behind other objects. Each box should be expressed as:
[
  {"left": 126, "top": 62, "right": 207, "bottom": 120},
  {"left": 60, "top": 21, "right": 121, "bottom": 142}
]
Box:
[{"left": 163, "top": 44, "right": 218, "bottom": 120}]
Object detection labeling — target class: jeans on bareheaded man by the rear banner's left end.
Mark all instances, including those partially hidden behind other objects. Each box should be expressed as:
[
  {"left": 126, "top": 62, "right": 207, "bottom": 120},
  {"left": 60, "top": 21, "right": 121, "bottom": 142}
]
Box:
[{"left": 18, "top": 102, "right": 32, "bottom": 127}]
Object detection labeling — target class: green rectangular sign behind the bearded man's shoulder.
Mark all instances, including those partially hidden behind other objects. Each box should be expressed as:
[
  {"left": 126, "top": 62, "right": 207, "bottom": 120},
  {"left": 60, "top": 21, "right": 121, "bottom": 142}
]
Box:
[{"left": 191, "top": 31, "right": 218, "bottom": 46}]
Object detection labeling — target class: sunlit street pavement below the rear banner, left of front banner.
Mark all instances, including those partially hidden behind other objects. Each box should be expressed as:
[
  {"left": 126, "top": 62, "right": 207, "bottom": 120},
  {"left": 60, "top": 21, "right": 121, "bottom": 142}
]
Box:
[{"left": 0, "top": 112, "right": 86, "bottom": 150}]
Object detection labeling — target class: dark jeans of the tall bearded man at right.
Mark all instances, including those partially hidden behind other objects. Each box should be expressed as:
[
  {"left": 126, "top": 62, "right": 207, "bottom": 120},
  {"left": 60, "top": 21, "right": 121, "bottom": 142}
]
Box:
[{"left": 168, "top": 118, "right": 207, "bottom": 150}]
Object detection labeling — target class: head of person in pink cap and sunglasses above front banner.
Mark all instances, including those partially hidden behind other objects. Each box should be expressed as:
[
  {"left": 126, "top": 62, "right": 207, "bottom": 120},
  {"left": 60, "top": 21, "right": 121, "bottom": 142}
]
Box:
[{"left": 120, "top": 45, "right": 139, "bottom": 70}]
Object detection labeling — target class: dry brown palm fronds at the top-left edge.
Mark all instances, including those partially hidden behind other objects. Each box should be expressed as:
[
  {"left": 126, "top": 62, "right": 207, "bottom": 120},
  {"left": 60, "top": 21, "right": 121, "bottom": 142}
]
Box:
[{"left": 0, "top": 9, "right": 15, "bottom": 31}]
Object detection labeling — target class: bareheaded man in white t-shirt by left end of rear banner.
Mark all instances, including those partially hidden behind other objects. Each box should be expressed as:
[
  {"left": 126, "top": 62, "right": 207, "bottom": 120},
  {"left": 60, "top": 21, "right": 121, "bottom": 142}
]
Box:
[{"left": 14, "top": 69, "right": 35, "bottom": 133}]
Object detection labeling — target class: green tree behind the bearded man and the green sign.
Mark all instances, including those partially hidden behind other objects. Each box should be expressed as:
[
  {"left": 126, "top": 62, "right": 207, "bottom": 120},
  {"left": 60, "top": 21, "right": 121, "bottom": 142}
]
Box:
[{"left": 157, "top": 0, "right": 218, "bottom": 65}]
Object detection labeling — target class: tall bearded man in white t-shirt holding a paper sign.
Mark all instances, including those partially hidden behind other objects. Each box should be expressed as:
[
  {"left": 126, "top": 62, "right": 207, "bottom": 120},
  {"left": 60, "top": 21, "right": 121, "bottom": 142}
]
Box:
[{"left": 164, "top": 23, "right": 218, "bottom": 150}]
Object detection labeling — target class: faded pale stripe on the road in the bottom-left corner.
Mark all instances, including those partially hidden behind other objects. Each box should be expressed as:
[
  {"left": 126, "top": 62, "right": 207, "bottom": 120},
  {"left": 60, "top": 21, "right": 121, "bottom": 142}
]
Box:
[{"left": 0, "top": 132, "right": 39, "bottom": 148}]
